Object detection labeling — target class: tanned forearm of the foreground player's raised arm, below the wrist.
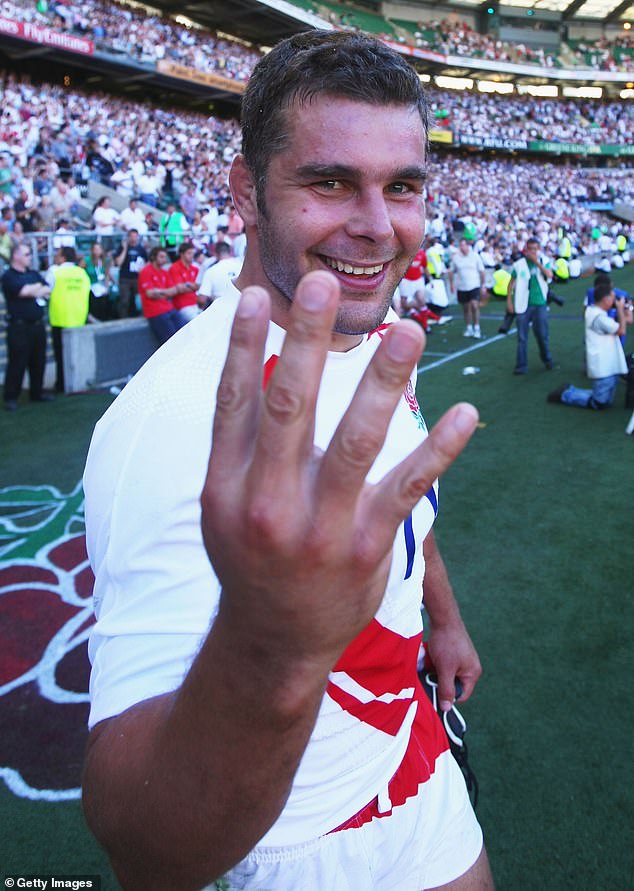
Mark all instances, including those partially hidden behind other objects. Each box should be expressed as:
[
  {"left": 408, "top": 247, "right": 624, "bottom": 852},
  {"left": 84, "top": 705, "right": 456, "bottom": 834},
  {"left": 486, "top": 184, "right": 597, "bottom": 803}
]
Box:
[{"left": 84, "top": 609, "right": 328, "bottom": 891}]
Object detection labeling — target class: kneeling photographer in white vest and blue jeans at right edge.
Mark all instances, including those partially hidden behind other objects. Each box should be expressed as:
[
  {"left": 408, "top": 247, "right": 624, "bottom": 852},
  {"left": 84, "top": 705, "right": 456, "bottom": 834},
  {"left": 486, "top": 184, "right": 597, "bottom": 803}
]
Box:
[{"left": 547, "top": 281, "right": 632, "bottom": 410}]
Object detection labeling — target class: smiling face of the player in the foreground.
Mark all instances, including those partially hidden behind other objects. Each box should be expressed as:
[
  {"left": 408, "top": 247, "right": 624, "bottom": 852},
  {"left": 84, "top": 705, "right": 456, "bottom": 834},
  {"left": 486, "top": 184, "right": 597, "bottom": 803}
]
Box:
[{"left": 252, "top": 97, "right": 426, "bottom": 348}]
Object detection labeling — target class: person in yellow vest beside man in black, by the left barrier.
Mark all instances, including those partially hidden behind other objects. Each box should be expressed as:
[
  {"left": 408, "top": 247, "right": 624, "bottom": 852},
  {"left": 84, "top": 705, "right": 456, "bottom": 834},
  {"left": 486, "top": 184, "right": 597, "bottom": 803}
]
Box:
[{"left": 48, "top": 247, "right": 90, "bottom": 393}]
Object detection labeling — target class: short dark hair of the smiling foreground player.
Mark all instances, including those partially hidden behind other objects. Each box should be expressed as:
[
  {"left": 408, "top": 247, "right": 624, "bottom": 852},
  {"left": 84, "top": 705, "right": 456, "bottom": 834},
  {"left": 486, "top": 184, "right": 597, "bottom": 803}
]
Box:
[{"left": 241, "top": 30, "right": 428, "bottom": 211}]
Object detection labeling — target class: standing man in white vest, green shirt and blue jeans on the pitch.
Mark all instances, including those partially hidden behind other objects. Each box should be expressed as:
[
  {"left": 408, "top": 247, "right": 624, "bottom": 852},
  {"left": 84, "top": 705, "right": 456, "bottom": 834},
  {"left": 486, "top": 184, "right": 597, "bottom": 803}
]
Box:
[{"left": 506, "top": 238, "right": 553, "bottom": 374}]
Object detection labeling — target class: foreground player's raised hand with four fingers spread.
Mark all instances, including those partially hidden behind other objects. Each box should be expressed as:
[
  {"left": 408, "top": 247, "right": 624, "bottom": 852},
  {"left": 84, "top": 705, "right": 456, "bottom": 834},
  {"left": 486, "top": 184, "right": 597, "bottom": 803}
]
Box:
[{"left": 201, "top": 272, "right": 477, "bottom": 672}]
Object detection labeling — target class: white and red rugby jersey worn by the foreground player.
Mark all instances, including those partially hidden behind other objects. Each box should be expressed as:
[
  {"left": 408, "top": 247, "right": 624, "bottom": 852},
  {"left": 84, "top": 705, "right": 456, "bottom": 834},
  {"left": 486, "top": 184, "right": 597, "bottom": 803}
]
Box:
[{"left": 84, "top": 290, "right": 447, "bottom": 845}]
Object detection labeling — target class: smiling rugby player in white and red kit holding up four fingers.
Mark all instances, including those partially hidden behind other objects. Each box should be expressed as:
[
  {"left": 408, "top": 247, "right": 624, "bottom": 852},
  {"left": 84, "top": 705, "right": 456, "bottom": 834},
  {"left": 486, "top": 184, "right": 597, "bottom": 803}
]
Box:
[{"left": 84, "top": 31, "right": 492, "bottom": 891}]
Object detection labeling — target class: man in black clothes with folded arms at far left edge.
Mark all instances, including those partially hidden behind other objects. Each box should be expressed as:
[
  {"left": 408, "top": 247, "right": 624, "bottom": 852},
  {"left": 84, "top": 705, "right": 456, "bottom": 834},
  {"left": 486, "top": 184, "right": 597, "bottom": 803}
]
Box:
[{"left": 0, "top": 243, "right": 52, "bottom": 411}]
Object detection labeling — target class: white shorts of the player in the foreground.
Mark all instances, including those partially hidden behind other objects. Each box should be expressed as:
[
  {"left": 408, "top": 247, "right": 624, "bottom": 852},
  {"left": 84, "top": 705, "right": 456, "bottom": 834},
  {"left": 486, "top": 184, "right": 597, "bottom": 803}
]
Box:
[{"left": 215, "top": 751, "right": 482, "bottom": 891}]
